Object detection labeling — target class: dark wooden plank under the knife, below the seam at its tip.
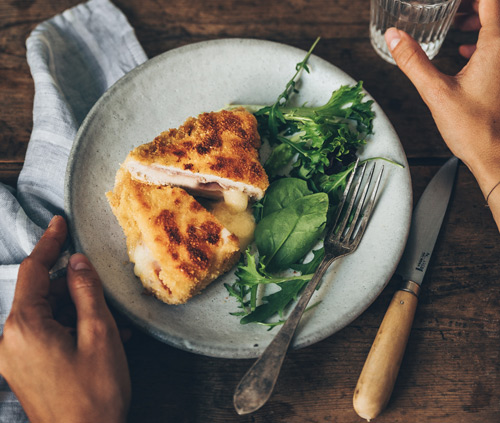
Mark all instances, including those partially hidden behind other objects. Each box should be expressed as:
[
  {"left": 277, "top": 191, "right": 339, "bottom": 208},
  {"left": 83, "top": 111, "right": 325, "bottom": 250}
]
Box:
[{"left": 120, "top": 165, "right": 500, "bottom": 423}]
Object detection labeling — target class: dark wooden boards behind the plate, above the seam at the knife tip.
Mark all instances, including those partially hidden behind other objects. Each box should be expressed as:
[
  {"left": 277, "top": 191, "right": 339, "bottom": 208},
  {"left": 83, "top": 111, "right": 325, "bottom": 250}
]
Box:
[{"left": 0, "top": 0, "right": 472, "bottom": 177}]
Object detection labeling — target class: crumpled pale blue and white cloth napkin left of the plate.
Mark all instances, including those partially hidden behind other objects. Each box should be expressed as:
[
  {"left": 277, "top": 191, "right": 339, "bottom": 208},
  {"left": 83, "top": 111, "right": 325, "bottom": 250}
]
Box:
[{"left": 0, "top": 0, "right": 147, "bottom": 423}]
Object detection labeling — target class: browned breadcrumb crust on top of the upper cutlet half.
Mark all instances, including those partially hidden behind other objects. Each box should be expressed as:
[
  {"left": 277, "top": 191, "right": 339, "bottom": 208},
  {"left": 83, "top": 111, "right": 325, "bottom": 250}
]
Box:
[{"left": 127, "top": 108, "right": 269, "bottom": 195}]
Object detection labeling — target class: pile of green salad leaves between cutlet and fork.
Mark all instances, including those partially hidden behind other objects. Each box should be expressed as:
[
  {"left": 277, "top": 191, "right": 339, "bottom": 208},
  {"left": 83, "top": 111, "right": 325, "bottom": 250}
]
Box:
[{"left": 225, "top": 40, "right": 386, "bottom": 328}]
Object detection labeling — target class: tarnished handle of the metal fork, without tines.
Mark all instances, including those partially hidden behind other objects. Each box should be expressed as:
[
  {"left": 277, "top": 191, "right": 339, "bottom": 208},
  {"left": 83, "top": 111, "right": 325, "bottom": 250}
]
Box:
[{"left": 233, "top": 257, "right": 334, "bottom": 415}]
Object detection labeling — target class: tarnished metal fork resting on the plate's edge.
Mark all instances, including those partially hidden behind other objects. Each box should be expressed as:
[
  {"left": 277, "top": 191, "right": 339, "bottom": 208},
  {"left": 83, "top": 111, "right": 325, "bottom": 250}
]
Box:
[{"left": 233, "top": 160, "right": 384, "bottom": 415}]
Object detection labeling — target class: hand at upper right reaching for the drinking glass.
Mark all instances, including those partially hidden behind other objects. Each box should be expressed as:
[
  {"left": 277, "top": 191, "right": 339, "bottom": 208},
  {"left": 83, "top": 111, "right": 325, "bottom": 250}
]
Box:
[{"left": 385, "top": 0, "right": 500, "bottom": 206}]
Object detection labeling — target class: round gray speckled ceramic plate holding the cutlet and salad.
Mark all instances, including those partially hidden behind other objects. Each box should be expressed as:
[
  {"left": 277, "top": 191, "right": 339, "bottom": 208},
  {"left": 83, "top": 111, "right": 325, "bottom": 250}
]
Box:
[{"left": 65, "top": 39, "right": 412, "bottom": 358}]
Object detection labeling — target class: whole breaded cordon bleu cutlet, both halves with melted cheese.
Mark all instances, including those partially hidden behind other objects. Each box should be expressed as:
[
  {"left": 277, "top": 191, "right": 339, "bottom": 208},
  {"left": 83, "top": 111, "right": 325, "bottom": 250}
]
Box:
[{"left": 106, "top": 109, "right": 269, "bottom": 304}]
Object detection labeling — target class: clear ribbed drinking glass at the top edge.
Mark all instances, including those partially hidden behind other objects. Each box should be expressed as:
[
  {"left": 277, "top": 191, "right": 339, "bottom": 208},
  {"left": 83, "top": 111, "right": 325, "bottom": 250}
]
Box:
[{"left": 370, "top": 0, "right": 460, "bottom": 64}]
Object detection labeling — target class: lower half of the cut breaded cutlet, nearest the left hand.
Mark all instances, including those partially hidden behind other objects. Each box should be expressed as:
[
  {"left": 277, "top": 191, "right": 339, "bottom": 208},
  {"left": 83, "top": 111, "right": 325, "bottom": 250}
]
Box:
[{"left": 106, "top": 168, "right": 240, "bottom": 304}]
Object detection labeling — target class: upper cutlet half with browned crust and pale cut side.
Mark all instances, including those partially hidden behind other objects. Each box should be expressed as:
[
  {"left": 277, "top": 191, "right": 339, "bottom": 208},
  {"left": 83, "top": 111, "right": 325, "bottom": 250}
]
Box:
[{"left": 124, "top": 108, "right": 269, "bottom": 210}]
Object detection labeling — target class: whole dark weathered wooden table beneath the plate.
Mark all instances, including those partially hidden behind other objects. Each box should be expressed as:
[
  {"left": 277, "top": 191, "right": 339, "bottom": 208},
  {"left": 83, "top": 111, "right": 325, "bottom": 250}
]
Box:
[{"left": 0, "top": 0, "right": 500, "bottom": 423}]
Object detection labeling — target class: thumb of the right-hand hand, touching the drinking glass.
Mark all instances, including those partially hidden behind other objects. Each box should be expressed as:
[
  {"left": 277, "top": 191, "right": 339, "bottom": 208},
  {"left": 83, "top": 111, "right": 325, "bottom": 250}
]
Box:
[{"left": 385, "top": 28, "right": 448, "bottom": 103}]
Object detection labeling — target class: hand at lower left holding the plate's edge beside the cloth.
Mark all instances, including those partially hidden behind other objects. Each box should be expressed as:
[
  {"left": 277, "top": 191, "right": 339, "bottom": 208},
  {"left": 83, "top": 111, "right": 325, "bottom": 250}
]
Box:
[{"left": 0, "top": 216, "right": 130, "bottom": 423}]
